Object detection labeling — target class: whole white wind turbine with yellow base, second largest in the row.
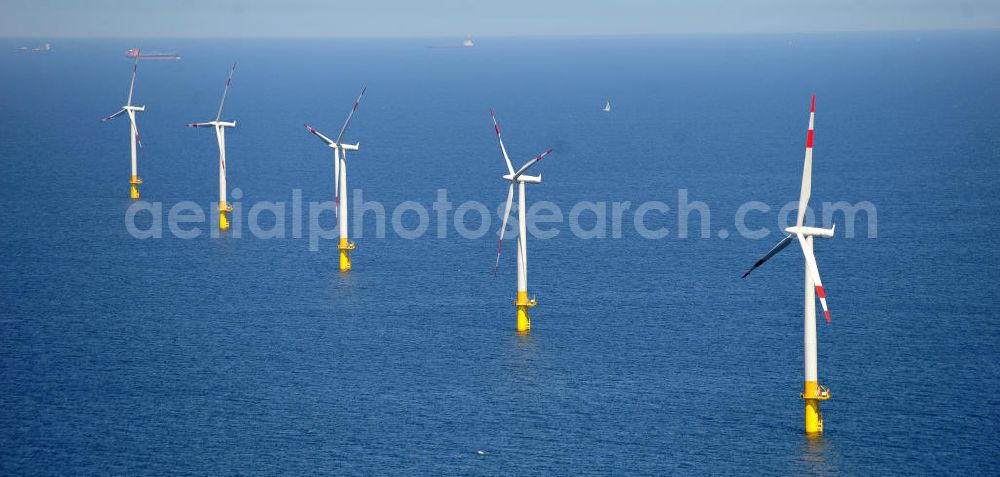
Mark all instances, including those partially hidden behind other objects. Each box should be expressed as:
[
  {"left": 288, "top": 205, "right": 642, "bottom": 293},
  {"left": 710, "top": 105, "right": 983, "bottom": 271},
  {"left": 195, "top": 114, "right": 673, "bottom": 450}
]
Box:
[{"left": 490, "top": 109, "right": 552, "bottom": 333}]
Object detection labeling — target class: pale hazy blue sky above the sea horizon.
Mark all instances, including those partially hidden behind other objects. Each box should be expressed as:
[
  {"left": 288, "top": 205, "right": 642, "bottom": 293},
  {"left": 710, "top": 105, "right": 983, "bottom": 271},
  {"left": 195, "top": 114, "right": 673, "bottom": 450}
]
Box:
[{"left": 0, "top": 0, "right": 1000, "bottom": 38}]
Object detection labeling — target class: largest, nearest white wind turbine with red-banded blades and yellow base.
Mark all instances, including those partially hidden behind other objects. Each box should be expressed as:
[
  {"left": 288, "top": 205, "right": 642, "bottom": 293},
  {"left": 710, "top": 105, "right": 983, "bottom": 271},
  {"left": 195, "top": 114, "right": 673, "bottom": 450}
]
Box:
[{"left": 743, "top": 95, "right": 836, "bottom": 435}]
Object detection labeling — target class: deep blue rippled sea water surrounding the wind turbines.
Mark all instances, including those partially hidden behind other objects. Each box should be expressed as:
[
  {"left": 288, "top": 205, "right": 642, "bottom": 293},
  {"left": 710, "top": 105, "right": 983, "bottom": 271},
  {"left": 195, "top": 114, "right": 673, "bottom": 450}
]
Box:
[{"left": 0, "top": 32, "right": 1000, "bottom": 475}]
